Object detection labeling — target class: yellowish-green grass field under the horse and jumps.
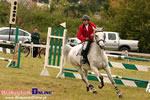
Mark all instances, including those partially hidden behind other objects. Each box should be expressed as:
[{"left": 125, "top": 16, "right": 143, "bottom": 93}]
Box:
[{"left": 0, "top": 53, "right": 150, "bottom": 100}]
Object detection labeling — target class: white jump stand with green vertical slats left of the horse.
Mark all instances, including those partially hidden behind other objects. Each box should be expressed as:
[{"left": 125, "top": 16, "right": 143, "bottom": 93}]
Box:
[{"left": 41, "top": 27, "right": 67, "bottom": 76}]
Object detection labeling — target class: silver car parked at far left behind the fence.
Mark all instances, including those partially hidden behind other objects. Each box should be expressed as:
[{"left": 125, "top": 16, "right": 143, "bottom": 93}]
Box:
[{"left": 0, "top": 27, "right": 31, "bottom": 43}]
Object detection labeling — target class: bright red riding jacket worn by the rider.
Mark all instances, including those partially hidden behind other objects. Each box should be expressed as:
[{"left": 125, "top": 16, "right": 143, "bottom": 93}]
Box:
[{"left": 77, "top": 22, "right": 96, "bottom": 42}]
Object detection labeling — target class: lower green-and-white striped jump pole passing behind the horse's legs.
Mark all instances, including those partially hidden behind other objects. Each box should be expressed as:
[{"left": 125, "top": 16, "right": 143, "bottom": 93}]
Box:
[{"left": 64, "top": 72, "right": 149, "bottom": 88}]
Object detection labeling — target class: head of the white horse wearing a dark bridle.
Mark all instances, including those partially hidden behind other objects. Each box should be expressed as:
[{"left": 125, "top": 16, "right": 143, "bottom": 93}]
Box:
[{"left": 94, "top": 27, "right": 105, "bottom": 49}]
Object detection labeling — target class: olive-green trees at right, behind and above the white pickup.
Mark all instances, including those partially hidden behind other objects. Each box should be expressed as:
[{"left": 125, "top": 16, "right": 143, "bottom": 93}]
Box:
[{"left": 101, "top": 0, "right": 150, "bottom": 52}]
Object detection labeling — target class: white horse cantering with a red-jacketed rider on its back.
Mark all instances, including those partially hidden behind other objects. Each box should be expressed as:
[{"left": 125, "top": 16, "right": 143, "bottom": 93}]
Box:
[{"left": 57, "top": 28, "right": 122, "bottom": 98}]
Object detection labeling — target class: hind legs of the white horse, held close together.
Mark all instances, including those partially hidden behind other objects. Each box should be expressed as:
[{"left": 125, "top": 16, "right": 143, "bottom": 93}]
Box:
[{"left": 78, "top": 68, "right": 97, "bottom": 93}]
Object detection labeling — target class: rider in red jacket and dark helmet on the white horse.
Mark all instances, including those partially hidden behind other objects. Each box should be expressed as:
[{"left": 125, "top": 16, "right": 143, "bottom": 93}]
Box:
[{"left": 77, "top": 15, "right": 96, "bottom": 64}]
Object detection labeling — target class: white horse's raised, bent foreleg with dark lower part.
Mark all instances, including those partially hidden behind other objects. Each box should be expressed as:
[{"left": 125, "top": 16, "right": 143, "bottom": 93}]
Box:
[{"left": 91, "top": 66, "right": 104, "bottom": 89}]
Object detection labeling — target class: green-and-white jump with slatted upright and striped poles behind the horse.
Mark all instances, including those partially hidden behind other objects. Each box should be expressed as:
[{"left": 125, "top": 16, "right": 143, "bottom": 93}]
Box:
[{"left": 40, "top": 27, "right": 150, "bottom": 91}]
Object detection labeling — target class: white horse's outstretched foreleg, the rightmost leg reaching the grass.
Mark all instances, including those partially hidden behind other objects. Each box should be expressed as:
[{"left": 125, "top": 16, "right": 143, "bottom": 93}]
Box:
[{"left": 105, "top": 66, "right": 122, "bottom": 98}]
